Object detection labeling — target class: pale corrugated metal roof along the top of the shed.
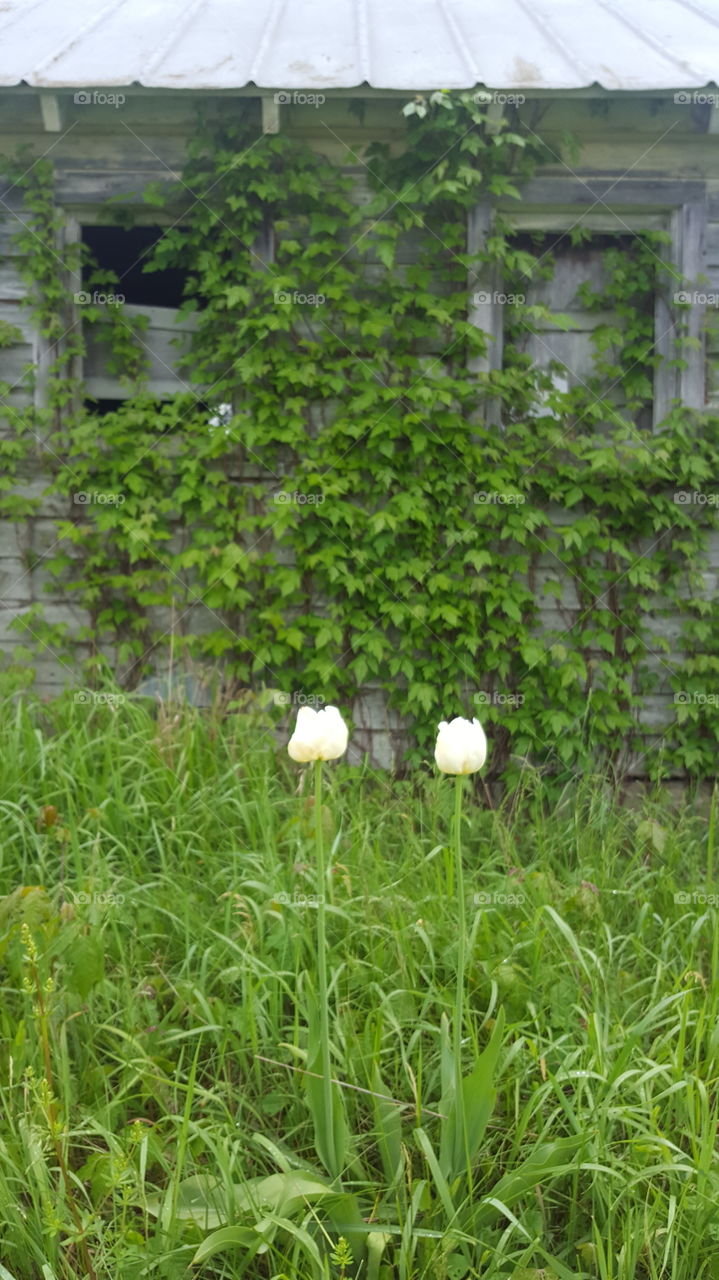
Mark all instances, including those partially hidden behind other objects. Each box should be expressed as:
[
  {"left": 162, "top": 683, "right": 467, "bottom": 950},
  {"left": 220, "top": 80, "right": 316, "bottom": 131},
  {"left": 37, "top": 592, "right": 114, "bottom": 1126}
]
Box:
[{"left": 0, "top": 0, "right": 719, "bottom": 91}]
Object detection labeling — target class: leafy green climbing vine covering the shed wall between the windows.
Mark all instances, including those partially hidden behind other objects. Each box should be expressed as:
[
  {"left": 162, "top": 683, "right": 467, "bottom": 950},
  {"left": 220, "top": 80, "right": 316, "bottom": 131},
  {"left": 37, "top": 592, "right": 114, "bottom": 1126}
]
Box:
[{"left": 1, "top": 93, "right": 719, "bottom": 773}]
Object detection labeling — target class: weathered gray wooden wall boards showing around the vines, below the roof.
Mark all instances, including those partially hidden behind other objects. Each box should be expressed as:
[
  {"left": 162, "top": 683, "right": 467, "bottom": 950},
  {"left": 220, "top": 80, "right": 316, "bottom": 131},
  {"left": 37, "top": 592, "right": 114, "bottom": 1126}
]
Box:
[{"left": 0, "top": 88, "right": 719, "bottom": 773}]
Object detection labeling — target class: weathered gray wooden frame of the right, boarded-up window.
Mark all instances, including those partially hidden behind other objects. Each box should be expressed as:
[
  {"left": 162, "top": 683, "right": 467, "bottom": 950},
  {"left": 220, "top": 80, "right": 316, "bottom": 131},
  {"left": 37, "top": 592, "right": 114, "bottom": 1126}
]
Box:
[{"left": 467, "top": 177, "right": 706, "bottom": 430}]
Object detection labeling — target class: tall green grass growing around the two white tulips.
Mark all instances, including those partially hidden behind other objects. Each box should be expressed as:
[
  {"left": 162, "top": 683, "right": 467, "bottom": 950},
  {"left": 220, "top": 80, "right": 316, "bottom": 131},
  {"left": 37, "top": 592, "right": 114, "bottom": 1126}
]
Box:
[{"left": 0, "top": 696, "right": 719, "bottom": 1280}]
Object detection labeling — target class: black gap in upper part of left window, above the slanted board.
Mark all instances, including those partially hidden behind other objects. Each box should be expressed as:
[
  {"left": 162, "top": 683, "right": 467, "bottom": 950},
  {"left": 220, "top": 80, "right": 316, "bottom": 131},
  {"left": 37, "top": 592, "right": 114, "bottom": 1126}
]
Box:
[{"left": 81, "top": 225, "right": 187, "bottom": 307}]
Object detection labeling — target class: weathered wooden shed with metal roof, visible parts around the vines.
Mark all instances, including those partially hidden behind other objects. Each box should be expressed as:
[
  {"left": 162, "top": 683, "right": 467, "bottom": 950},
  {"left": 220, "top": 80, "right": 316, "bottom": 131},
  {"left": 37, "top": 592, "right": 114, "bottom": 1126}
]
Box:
[{"left": 0, "top": 0, "right": 719, "bottom": 772}]
